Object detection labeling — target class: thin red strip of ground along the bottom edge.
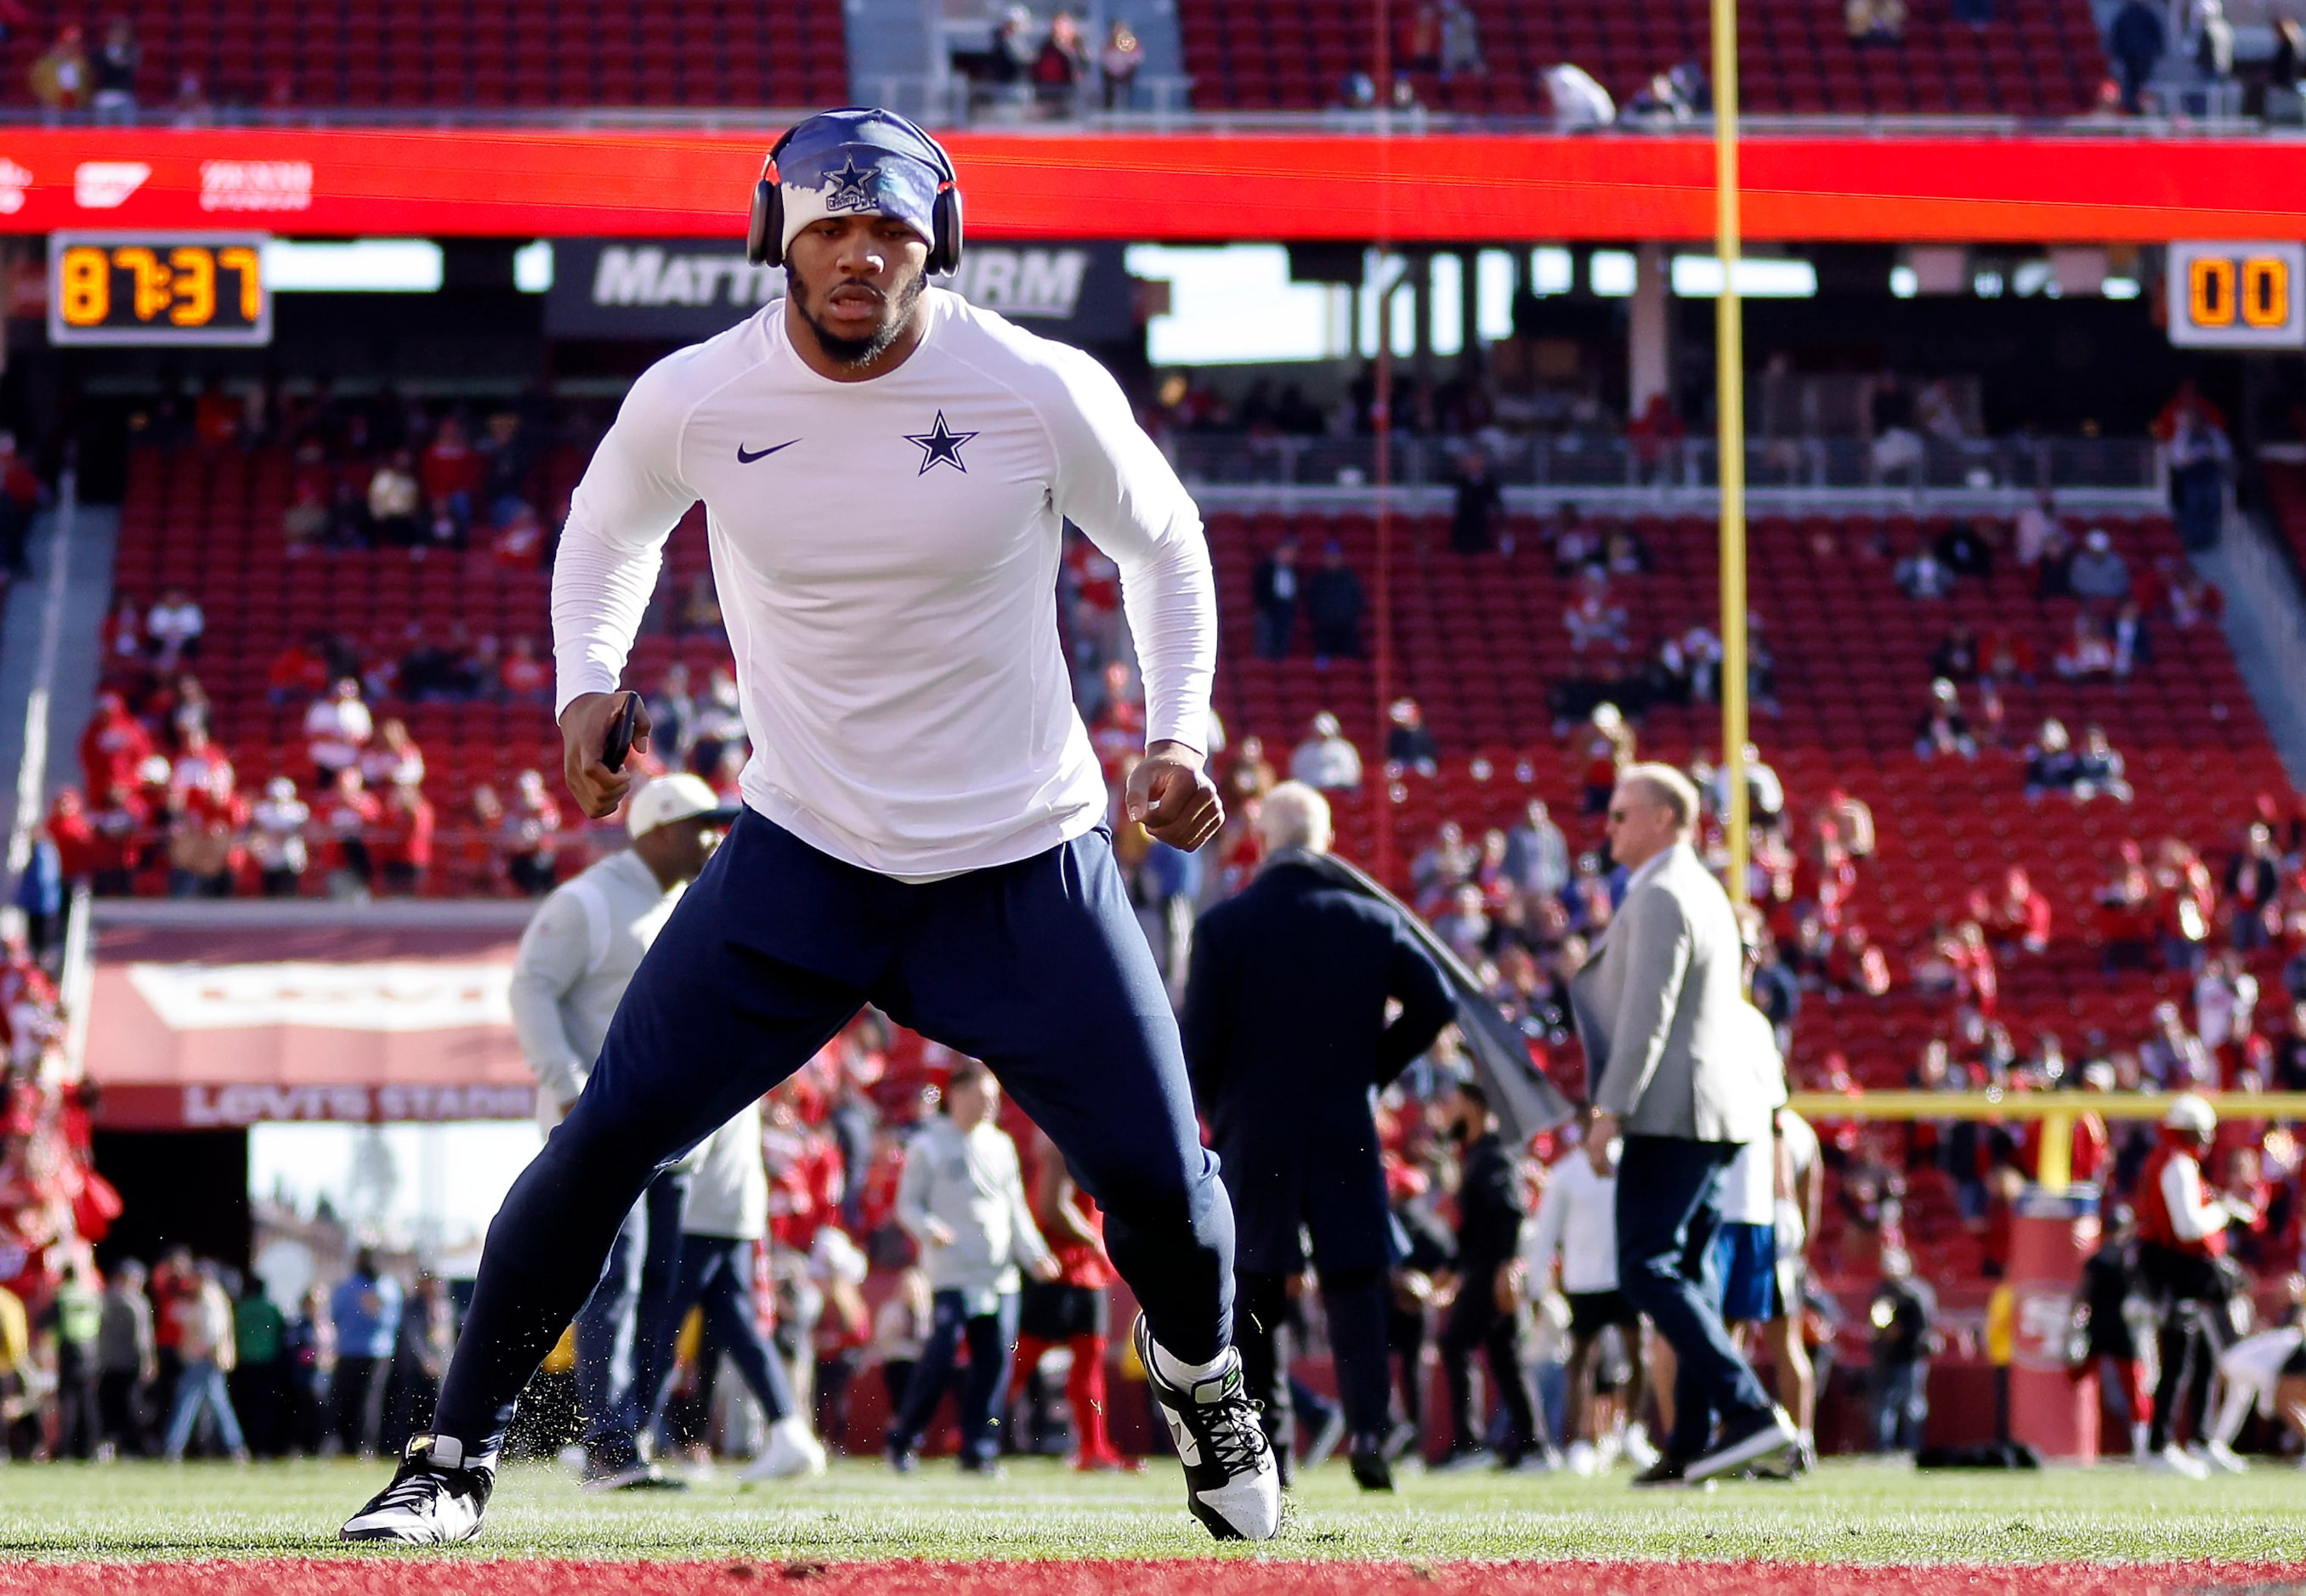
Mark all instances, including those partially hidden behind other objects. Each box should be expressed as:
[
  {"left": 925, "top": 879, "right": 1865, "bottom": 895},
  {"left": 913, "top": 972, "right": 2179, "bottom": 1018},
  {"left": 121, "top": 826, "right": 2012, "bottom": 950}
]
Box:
[{"left": 0, "top": 1552, "right": 2306, "bottom": 1596}]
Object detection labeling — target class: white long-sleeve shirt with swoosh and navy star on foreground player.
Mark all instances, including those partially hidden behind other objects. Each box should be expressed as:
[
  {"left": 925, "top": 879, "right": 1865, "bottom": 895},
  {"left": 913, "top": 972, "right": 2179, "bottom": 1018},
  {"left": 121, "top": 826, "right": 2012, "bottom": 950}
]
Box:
[{"left": 553, "top": 288, "right": 1217, "bottom": 881}]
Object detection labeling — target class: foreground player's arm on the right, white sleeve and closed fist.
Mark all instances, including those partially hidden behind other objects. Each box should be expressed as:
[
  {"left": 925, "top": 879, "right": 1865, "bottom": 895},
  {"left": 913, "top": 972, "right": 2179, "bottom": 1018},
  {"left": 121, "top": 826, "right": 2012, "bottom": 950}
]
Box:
[{"left": 1047, "top": 351, "right": 1225, "bottom": 853}]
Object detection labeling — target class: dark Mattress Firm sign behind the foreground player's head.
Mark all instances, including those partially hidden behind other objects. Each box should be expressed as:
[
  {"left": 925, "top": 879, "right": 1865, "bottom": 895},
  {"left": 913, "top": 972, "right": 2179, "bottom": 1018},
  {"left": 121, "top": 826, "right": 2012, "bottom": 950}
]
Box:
[{"left": 544, "top": 238, "right": 1135, "bottom": 343}]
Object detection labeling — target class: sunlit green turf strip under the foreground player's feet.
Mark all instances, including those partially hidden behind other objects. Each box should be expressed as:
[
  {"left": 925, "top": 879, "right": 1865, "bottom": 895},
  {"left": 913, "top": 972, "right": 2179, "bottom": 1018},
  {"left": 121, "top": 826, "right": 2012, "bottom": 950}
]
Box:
[{"left": 0, "top": 1463, "right": 2306, "bottom": 1561}]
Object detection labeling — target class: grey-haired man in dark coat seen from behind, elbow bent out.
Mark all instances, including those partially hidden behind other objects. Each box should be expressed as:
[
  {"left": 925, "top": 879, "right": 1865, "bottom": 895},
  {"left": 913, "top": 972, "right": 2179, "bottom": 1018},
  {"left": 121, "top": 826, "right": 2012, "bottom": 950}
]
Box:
[{"left": 1183, "top": 782, "right": 1453, "bottom": 1490}]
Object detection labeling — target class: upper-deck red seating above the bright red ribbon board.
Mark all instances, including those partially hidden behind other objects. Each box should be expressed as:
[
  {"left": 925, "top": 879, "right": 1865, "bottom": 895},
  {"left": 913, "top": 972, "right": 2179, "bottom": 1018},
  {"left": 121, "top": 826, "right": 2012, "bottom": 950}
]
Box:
[{"left": 0, "top": 0, "right": 2269, "bottom": 127}]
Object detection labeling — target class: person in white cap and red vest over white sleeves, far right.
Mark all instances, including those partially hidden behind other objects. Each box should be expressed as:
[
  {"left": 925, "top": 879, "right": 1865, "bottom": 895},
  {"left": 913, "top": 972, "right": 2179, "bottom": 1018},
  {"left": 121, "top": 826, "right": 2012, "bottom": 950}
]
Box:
[{"left": 2138, "top": 1091, "right": 2255, "bottom": 1479}]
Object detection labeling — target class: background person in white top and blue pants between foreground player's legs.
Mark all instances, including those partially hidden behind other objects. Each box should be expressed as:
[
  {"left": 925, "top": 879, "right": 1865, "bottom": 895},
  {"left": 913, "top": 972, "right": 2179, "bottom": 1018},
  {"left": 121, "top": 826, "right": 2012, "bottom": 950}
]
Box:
[{"left": 883, "top": 1059, "right": 1057, "bottom": 1474}]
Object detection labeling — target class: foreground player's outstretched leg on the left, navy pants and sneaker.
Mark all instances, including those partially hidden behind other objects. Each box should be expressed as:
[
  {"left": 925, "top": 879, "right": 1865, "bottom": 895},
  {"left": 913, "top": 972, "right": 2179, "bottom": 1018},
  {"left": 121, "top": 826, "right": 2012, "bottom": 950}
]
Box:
[{"left": 343, "top": 812, "right": 892, "bottom": 1543}]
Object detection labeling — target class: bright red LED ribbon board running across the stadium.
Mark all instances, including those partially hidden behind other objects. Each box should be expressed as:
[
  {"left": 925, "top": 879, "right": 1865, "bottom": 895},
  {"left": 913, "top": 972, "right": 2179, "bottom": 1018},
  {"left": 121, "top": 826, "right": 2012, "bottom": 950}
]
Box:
[{"left": 0, "top": 127, "right": 2306, "bottom": 245}]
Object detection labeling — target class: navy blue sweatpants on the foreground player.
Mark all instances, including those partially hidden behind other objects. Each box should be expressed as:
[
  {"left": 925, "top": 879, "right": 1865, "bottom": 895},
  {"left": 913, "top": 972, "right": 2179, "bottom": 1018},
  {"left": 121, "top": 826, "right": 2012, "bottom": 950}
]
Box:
[{"left": 438, "top": 810, "right": 1233, "bottom": 1455}]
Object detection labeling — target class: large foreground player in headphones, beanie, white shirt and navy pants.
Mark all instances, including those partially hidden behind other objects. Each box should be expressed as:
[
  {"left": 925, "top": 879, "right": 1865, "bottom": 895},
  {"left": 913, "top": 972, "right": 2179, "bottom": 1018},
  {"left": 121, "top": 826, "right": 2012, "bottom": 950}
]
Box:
[{"left": 343, "top": 110, "right": 1280, "bottom": 1543}]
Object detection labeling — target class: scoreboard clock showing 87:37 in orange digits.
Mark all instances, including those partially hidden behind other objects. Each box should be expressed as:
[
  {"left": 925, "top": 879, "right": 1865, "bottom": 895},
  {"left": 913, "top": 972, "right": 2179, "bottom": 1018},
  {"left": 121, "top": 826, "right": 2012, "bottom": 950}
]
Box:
[{"left": 48, "top": 233, "right": 272, "bottom": 346}]
